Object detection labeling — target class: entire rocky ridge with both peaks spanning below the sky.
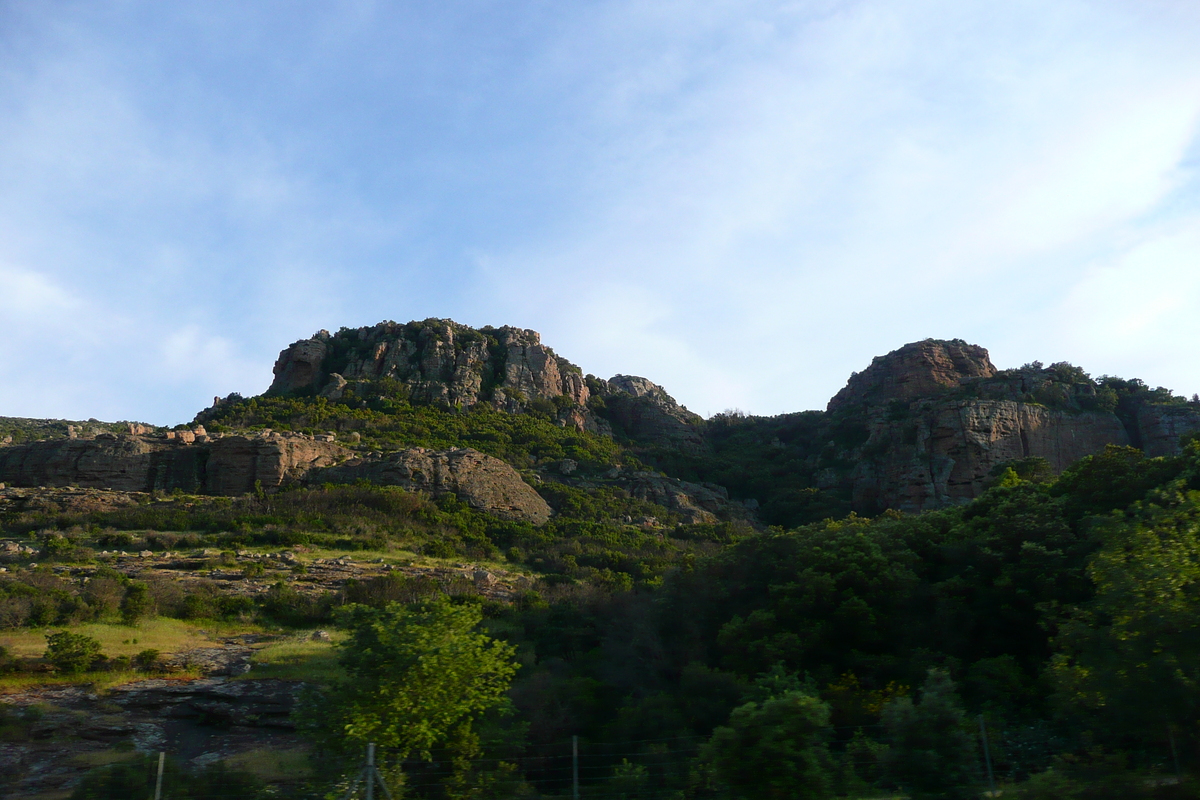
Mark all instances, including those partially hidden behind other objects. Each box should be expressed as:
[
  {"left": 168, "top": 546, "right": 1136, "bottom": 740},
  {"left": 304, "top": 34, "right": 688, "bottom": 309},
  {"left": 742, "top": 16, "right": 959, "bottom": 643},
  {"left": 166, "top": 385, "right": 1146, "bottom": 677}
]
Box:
[{"left": 0, "top": 319, "right": 1200, "bottom": 525}]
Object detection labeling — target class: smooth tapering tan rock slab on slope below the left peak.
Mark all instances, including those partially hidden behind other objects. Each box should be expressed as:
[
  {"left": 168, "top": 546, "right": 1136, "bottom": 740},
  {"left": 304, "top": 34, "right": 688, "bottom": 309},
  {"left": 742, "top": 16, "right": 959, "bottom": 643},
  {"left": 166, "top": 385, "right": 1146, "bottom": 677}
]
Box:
[{"left": 310, "top": 447, "right": 551, "bottom": 524}]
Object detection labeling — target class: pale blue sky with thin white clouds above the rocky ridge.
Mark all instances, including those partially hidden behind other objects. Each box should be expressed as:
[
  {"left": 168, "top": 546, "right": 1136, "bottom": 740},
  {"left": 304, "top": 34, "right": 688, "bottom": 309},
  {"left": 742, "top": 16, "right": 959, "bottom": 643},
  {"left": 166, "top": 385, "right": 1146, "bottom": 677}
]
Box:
[{"left": 0, "top": 0, "right": 1200, "bottom": 425}]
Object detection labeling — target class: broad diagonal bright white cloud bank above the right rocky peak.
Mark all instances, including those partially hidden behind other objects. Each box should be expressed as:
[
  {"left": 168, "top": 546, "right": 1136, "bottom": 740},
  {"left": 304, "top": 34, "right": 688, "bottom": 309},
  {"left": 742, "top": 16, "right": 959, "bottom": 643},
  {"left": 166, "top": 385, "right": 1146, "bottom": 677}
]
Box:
[{"left": 472, "top": 2, "right": 1200, "bottom": 413}]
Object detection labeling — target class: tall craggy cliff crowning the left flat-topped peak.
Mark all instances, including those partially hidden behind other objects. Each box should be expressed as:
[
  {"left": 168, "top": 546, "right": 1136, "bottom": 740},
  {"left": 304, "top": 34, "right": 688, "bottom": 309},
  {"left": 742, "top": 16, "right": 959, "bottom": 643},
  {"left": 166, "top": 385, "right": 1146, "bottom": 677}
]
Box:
[{"left": 269, "top": 319, "right": 589, "bottom": 425}]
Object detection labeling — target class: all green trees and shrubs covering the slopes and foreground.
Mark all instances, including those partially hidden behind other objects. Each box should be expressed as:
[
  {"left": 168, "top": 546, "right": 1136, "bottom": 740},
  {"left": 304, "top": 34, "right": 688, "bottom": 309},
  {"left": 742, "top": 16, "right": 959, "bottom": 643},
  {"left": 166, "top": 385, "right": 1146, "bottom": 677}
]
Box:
[{"left": 0, "top": 371, "right": 1200, "bottom": 800}]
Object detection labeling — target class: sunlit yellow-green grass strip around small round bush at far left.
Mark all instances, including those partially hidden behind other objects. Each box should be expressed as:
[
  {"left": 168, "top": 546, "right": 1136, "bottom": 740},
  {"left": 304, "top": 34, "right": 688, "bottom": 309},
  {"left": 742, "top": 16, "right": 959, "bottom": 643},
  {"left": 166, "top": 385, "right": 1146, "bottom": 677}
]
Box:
[{"left": 0, "top": 616, "right": 260, "bottom": 658}]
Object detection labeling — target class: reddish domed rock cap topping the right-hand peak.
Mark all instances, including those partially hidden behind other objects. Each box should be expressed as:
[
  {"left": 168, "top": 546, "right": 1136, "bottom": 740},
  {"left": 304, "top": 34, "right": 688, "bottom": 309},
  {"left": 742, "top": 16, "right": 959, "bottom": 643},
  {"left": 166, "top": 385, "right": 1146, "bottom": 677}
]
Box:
[{"left": 828, "top": 339, "right": 996, "bottom": 413}]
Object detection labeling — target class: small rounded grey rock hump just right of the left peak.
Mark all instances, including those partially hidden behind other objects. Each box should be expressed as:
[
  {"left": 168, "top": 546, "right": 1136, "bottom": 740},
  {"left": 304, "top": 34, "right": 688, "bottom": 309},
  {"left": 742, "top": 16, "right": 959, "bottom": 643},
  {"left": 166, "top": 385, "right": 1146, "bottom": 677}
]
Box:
[{"left": 605, "top": 375, "right": 707, "bottom": 455}]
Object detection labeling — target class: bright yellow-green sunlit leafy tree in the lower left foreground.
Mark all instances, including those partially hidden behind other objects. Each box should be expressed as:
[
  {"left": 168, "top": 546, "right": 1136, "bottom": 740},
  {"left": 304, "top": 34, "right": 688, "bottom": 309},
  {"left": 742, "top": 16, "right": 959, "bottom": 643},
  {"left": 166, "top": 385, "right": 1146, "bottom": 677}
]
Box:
[{"left": 304, "top": 600, "right": 517, "bottom": 759}]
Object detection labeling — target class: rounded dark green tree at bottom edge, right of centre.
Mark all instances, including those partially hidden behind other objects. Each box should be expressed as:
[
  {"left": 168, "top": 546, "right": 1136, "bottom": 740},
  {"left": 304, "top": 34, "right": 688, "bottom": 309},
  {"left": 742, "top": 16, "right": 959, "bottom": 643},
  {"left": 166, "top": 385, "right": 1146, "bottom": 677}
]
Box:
[{"left": 703, "top": 691, "right": 832, "bottom": 800}]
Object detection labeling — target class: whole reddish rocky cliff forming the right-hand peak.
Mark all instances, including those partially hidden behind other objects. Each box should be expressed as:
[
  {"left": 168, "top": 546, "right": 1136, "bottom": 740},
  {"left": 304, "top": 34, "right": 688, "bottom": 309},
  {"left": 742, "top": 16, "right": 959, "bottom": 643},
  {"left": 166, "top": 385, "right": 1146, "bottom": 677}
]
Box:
[{"left": 816, "top": 339, "right": 1200, "bottom": 511}]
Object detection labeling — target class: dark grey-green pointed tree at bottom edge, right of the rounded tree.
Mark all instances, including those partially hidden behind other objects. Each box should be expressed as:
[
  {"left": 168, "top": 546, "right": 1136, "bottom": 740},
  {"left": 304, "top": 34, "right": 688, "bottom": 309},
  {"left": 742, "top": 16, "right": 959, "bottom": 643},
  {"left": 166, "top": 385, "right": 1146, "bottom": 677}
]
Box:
[{"left": 883, "top": 669, "right": 977, "bottom": 800}]
